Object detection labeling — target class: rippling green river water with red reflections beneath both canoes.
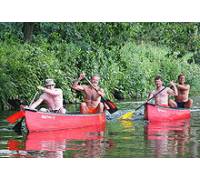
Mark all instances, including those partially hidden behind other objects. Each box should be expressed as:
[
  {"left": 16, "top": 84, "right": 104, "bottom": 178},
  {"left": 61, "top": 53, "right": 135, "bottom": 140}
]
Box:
[{"left": 0, "top": 98, "right": 200, "bottom": 158}]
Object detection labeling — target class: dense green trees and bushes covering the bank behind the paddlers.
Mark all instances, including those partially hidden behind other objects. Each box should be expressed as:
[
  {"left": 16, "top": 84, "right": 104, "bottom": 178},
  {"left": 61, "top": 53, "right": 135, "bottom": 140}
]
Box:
[{"left": 0, "top": 22, "right": 200, "bottom": 109}]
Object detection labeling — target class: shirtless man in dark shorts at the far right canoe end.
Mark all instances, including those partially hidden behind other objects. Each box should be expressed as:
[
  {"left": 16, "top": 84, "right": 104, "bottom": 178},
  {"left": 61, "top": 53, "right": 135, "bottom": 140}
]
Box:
[{"left": 175, "top": 73, "right": 193, "bottom": 108}]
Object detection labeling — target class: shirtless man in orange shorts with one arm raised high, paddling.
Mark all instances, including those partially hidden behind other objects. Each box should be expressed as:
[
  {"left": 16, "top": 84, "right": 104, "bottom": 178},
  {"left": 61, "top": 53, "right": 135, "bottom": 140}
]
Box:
[{"left": 72, "top": 73, "right": 104, "bottom": 114}]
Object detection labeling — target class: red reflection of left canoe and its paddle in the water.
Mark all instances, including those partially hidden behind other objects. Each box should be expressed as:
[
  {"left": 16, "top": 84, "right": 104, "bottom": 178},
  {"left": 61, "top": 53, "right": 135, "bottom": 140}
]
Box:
[{"left": 7, "top": 127, "right": 107, "bottom": 158}]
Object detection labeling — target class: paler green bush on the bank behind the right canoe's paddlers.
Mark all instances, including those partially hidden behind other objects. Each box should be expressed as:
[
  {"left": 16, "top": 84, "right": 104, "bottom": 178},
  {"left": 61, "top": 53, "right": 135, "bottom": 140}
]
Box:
[{"left": 120, "top": 43, "right": 200, "bottom": 98}]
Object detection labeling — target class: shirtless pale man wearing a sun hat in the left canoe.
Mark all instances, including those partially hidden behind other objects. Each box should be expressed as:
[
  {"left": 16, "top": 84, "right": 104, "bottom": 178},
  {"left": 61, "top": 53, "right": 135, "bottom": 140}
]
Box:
[{"left": 29, "top": 79, "right": 66, "bottom": 114}]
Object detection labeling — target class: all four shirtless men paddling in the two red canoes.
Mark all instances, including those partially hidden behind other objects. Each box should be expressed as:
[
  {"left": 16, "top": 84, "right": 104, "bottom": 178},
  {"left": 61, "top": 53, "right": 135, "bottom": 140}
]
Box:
[{"left": 29, "top": 73, "right": 193, "bottom": 114}]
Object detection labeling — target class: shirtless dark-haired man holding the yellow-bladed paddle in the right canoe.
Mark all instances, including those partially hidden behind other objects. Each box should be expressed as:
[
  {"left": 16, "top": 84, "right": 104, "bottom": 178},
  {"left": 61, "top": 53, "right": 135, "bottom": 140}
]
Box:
[{"left": 147, "top": 76, "right": 178, "bottom": 107}]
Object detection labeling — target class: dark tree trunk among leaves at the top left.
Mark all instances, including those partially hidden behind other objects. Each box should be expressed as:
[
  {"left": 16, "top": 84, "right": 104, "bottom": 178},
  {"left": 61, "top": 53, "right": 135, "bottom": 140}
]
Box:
[{"left": 22, "top": 22, "right": 35, "bottom": 42}]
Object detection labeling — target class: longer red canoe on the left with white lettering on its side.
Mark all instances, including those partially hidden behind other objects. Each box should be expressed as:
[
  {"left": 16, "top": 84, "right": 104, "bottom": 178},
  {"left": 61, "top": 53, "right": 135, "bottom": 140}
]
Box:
[{"left": 25, "top": 110, "right": 106, "bottom": 132}]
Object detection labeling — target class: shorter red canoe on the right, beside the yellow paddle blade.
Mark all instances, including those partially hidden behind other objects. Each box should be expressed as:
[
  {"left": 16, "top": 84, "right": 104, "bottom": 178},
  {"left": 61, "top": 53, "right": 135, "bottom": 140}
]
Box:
[{"left": 144, "top": 103, "right": 191, "bottom": 122}]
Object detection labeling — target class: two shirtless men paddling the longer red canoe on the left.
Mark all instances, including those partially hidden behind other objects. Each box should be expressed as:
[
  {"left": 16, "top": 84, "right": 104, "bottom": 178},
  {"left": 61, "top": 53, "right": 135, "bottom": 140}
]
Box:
[{"left": 29, "top": 73, "right": 105, "bottom": 114}]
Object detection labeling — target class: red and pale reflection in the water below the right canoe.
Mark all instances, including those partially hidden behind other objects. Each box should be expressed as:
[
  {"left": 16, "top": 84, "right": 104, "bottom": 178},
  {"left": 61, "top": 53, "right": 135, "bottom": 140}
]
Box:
[{"left": 145, "top": 120, "right": 190, "bottom": 157}]
